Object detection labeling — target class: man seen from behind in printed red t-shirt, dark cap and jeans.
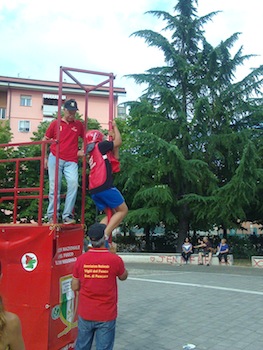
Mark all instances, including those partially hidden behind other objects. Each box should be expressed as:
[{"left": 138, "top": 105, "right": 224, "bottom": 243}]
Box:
[{"left": 71, "top": 223, "right": 128, "bottom": 350}]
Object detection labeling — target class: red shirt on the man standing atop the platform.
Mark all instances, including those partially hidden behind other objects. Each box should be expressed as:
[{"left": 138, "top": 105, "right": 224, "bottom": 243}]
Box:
[{"left": 46, "top": 119, "right": 84, "bottom": 163}]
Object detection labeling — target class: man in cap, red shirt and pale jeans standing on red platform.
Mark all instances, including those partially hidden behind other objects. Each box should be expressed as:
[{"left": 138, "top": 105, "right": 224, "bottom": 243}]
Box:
[{"left": 43, "top": 99, "right": 84, "bottom": 224}]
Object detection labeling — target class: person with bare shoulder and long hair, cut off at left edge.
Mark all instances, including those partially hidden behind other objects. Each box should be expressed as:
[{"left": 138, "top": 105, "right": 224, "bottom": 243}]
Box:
[{"left": 0, "top": 262, "right": 25, "bottom": 350}]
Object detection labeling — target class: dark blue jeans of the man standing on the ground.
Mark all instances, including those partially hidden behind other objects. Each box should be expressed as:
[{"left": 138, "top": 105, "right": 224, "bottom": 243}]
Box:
[{"left": 75, "top": 316, "right": 116, "bottom": 350}]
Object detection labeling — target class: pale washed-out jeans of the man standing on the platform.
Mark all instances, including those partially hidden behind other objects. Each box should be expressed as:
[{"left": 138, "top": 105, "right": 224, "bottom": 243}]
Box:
[{"left": 47, "top": 153, "right": 78, "bottom": 219}]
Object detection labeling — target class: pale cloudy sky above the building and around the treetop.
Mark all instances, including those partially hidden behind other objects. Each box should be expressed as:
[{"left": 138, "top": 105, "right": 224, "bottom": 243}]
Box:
[{"left": 0, "top": 0, "right": 263, "bottom": 102}]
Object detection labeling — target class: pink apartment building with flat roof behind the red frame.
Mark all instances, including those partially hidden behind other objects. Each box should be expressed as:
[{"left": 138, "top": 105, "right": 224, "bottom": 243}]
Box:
[{"left": 0, "top": 76, "right": 126, "bottom": 143}]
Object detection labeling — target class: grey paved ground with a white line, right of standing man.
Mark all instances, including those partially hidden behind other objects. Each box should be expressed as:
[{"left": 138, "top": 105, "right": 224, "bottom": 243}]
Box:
[{"left": 106, "top": 263, "right": 263, "bottom": 350}]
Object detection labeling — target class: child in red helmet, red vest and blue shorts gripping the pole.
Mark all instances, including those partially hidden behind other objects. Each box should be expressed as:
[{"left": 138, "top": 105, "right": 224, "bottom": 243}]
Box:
[{"left": 86, "top": 121, "right": 128, "bottom": 246}]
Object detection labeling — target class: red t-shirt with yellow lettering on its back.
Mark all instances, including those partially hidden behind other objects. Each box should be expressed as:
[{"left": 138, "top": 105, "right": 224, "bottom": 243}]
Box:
[{"left": 73, "top": 248, "right": 125, "bottom": 322}]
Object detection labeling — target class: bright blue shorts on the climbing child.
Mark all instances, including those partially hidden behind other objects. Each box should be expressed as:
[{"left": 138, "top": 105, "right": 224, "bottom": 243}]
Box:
[{"left": 91, "top": 187, "right": 124, "bottom": 211}]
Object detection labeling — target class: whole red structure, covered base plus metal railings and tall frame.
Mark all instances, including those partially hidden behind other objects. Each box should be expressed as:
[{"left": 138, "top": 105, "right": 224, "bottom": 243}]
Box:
[{"left": 0, "top": 67, "right": 114, "bottom": 350}]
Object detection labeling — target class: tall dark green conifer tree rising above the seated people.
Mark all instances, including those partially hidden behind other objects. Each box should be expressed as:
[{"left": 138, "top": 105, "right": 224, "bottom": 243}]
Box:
[{"left": 117, "top": 0, "right": 263, "bottom": 250}]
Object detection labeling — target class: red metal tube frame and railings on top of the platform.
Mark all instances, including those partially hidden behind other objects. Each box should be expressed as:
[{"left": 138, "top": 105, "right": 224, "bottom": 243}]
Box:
[{"left": 0, "top": 66, "right": 115, "bottom": 226}]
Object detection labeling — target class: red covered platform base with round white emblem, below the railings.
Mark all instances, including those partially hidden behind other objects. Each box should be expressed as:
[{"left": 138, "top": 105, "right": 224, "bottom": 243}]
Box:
[{"left": 0, "top": 224, "right": 84, "bottom": 350}]
